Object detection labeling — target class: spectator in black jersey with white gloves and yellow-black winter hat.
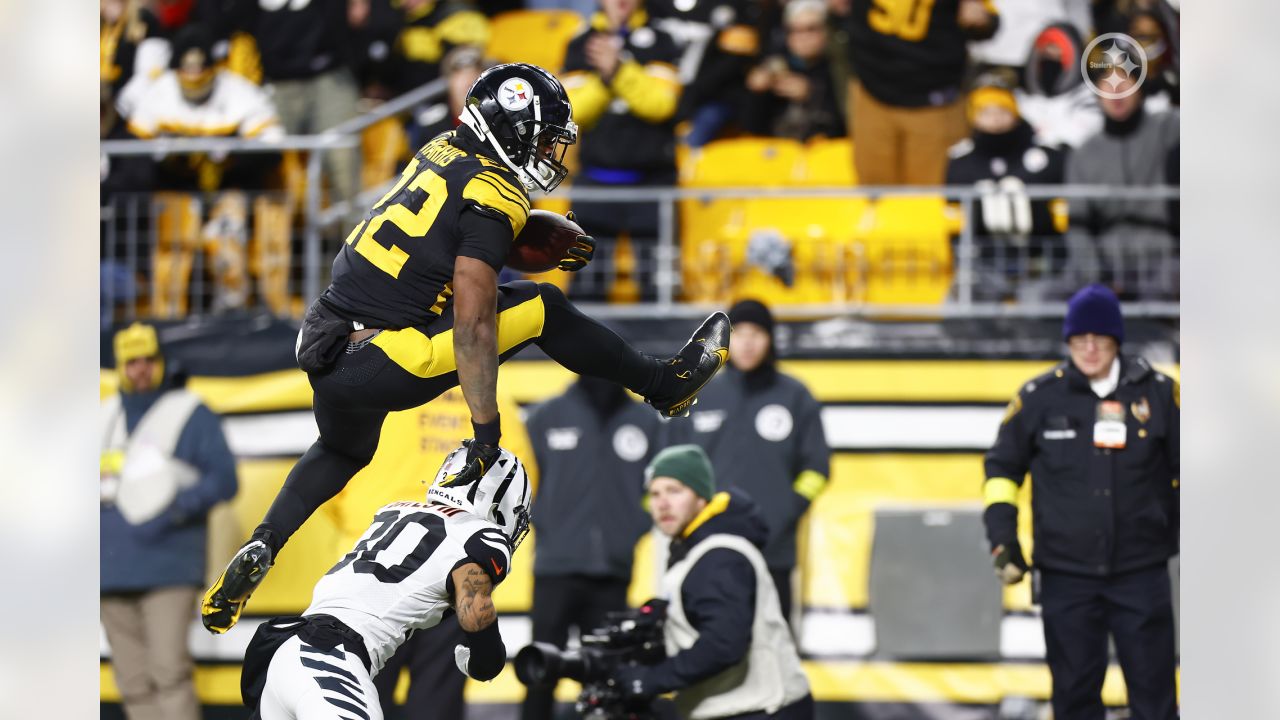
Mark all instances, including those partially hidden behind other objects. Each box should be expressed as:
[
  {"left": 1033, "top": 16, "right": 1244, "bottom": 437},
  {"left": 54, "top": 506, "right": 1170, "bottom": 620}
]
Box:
[{"left": 947, "top": 73, "right": 1066, "bottom": 300}]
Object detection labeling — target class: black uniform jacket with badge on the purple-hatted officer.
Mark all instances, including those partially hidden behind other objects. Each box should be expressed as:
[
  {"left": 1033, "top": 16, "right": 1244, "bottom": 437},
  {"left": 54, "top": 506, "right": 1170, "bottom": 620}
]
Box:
[{"left": 986, "top": 356, "right": 1180, "bottom": 577}]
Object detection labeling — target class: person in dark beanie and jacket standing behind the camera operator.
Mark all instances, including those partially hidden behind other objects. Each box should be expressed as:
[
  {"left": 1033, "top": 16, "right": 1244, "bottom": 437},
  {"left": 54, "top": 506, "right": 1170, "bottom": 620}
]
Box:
[{"left": 675, "top": 300, "right": 831, "bottom": 620}]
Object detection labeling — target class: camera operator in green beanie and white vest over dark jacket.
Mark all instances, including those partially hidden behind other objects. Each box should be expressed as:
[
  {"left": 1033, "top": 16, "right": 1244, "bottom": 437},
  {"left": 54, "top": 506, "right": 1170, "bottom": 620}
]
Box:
[{"left": 609, "top": 445, "right": 814, "bottom": 720}]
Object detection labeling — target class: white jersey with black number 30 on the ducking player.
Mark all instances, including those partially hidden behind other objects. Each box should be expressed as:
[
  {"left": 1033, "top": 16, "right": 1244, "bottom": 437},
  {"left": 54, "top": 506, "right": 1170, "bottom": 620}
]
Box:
[{"left": 303, "top": 502, "right": 511, "bottom": 675}]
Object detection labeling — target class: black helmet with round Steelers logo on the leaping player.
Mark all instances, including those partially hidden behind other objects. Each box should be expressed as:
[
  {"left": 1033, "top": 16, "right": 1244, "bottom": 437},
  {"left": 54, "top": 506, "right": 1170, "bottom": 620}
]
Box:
[{"left": 458, "top": 63, "right": 577, "bottom": 192}]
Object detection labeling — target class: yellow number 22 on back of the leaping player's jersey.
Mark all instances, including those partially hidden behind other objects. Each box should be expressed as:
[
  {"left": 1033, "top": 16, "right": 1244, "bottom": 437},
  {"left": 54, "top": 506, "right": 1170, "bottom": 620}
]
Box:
[{"left": 347, "top": 159, "right": 448, "bottom": 279}]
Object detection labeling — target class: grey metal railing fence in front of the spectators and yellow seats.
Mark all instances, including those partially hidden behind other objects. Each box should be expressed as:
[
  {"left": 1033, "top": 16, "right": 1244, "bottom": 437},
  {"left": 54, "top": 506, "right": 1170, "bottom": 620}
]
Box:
[{"left": 100, "top": 82, "right": 1179, "bottom": 323}]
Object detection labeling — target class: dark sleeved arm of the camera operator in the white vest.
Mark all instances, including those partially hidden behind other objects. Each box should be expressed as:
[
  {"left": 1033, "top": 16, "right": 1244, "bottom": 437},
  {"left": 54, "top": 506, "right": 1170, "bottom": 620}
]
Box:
[{"left": 649, "top": 548, "right": 755, "bottom": 693}]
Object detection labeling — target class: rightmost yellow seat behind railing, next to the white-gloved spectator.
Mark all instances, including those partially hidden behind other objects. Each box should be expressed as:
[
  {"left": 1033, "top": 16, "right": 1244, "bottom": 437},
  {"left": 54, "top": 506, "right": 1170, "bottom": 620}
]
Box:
[{"left": 855, "top": 197, "right": 951, "bottom": 305}]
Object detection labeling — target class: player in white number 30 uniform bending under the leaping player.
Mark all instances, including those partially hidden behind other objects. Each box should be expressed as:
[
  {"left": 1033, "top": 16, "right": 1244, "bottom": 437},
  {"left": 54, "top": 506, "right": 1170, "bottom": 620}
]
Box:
[{"left": 241, "top": 447, "right": 531, "bottom": 720}]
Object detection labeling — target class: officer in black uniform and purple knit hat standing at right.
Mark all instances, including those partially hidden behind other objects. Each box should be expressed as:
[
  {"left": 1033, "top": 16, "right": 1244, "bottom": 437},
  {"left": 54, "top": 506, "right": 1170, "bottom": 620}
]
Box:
[{"left": 983, "top": 284, "right": 1180, "bottom": 720}]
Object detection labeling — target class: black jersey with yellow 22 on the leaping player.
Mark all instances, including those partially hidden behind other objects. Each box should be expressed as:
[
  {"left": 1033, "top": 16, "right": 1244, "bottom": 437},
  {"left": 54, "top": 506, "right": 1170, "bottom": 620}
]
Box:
[{"left": 321, "top": 132, "right": 529, "bottom": 329}]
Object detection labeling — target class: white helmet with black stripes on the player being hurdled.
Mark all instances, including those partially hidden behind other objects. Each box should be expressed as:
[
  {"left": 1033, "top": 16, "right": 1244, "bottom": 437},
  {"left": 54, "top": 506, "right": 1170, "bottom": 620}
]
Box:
[{"left": 426, "top": 446, "right": 532, "bottom": 552}]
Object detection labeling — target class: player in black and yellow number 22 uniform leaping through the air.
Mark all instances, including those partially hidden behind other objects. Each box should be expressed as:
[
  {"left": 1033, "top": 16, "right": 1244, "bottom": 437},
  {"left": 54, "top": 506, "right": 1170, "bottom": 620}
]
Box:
[{"left": 201, "top": 63, "right": 730, "bottom": 633}]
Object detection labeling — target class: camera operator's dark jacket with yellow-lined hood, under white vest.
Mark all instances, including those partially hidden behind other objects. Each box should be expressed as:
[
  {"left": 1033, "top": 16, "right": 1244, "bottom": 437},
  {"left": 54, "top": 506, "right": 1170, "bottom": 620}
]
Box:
[{"left": 644, "top": 489, "right": 769, "bottom": 693}]
